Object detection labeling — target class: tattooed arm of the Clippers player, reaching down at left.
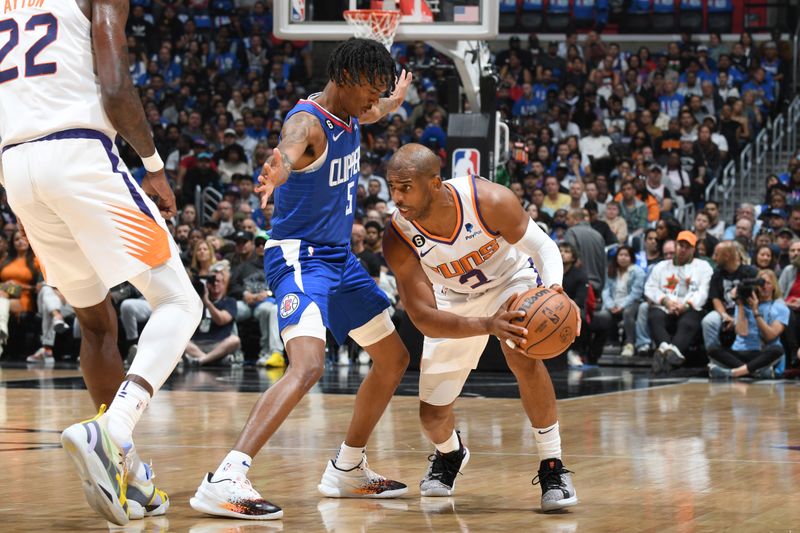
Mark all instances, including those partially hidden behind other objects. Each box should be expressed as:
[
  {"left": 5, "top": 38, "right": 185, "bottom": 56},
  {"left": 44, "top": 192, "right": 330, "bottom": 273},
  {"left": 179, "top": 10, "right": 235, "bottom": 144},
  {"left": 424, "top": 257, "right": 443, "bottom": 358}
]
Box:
[{"left": 255, "top": 113, "right": 328, "bottom": 209}]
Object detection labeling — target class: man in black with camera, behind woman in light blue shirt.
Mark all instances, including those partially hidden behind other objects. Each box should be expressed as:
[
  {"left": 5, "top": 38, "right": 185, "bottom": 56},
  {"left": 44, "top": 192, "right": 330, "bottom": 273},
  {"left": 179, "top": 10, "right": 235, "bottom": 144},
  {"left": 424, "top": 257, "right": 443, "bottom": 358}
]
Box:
[{"left": 701, "top": 241, "right": 758, "bottom": 353}]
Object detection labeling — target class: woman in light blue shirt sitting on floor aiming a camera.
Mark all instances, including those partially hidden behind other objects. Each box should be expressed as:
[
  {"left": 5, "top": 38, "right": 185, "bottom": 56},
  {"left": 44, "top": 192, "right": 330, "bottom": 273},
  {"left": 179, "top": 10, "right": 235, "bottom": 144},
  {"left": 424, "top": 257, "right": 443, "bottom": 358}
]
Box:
[{"left": 708, "top": 270, "right": 789, "bottom": 379}]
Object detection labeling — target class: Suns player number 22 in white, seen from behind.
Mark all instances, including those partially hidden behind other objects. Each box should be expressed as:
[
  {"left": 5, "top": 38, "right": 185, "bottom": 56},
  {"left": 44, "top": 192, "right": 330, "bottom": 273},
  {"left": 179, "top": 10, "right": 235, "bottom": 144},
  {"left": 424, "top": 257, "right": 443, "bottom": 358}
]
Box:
[{"left": 0, "top": 0, "right": 202, "bottom": 525}]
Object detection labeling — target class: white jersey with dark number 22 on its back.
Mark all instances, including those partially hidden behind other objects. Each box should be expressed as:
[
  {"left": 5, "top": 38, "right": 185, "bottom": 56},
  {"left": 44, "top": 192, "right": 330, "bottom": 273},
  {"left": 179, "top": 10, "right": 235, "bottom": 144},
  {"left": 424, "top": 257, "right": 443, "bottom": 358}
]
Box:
[{"left": 0, "top": 0, "right": 116, "bottom": 146}]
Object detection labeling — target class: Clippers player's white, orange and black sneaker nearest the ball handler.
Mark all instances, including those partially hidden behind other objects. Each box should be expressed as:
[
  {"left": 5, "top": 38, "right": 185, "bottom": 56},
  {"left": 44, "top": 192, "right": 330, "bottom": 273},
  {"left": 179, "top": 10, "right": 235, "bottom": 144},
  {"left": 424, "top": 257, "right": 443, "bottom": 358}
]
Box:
[{"left": 317, "top": 455, "right": 408, "bottom": 498}]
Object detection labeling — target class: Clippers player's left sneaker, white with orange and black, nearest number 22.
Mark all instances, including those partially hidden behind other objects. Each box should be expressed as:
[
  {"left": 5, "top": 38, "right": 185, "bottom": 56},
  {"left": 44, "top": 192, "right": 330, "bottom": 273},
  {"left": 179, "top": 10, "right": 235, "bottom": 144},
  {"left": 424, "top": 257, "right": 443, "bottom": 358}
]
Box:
[{"left": 189, "top": 472, "right": 283, "bottom": 520}]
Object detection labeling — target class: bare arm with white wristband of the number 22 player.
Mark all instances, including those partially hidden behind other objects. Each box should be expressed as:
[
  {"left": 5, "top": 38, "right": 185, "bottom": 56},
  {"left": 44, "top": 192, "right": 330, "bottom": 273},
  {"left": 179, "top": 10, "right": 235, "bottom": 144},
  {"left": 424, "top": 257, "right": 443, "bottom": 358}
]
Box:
[{"left": 92, "top": 0, "right": 176, "bottom": 218}]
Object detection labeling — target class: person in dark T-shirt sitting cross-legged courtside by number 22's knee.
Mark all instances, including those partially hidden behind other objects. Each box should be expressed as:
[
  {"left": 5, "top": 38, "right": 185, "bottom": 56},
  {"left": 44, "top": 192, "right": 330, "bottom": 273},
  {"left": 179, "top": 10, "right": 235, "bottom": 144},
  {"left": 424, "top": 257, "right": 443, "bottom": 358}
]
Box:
[{"left": 185, "top": 272, "right": 241, "bottom": 366}]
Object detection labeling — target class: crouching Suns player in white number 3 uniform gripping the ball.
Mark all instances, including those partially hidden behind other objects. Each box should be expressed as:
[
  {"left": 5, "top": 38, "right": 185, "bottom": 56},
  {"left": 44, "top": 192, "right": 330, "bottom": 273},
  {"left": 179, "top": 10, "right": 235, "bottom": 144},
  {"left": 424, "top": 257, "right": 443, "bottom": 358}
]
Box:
[{"left": 383, "top": 144, "right": 578, "bottom": 511}]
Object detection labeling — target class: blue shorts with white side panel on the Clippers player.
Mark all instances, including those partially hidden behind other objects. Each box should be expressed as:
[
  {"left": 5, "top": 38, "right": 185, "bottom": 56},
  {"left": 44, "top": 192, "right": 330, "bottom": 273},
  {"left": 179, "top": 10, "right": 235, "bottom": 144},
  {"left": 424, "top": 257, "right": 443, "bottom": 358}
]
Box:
[{"left": 264, "top": 239, "right": 390, "bottom": 344}]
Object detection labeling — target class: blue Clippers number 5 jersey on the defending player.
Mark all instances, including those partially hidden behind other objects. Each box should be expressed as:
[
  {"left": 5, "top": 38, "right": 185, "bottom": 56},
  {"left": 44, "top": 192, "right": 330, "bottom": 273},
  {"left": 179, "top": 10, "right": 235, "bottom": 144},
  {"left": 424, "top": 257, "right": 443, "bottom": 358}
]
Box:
[{"left": 272, "top": 95, "right": 361, "bottom": 246}]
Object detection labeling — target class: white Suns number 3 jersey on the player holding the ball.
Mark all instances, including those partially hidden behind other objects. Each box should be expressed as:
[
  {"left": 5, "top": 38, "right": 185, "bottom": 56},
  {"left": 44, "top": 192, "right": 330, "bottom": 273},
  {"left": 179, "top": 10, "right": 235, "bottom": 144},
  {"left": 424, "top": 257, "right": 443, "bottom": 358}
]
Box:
[{"left": 392, "top": 176, "right": 541, "bottom": 294}]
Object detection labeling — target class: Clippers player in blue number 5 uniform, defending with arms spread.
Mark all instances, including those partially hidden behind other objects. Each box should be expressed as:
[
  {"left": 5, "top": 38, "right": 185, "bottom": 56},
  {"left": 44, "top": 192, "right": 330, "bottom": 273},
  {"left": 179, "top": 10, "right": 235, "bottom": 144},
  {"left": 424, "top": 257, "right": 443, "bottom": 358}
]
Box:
[{"left": 190, "top": 39, "right": 411, "bottom": 520}]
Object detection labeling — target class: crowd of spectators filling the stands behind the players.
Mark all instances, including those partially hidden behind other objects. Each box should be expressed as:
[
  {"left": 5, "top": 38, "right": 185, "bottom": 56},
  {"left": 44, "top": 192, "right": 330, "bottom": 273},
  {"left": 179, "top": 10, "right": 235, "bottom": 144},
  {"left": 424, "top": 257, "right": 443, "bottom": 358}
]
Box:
[{"left": 0, "top": 0, "right": 800, "bottom": 376}]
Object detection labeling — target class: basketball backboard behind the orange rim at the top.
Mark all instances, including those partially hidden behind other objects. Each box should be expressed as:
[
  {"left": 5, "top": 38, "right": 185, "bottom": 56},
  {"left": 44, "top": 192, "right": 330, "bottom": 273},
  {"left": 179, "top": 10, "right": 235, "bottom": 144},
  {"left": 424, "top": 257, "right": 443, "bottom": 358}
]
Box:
[{"left": 273, "top": 0, "right": 499, "bottom": 41}]
